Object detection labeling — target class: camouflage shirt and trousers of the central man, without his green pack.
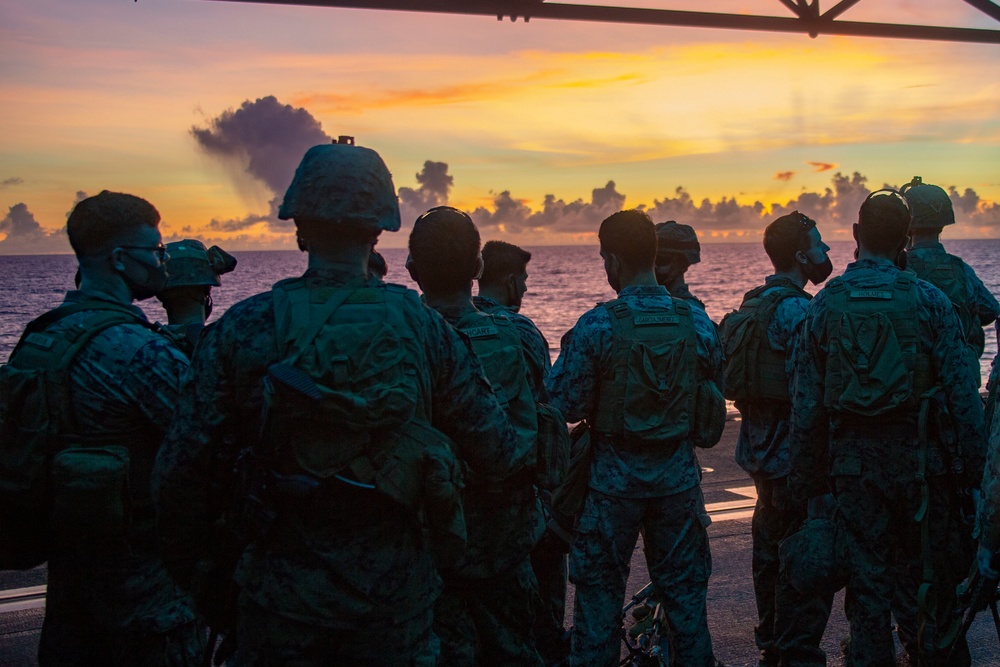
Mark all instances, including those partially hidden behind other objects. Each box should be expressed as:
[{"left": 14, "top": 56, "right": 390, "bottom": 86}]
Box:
[{"left": 548, "top": 285, "right": 722, "bottom": 667}]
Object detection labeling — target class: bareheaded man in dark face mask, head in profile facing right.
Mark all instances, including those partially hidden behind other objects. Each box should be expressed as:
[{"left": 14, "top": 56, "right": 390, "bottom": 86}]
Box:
[{"left": 719, "top": 211, "right": 833, "bottom": 667}]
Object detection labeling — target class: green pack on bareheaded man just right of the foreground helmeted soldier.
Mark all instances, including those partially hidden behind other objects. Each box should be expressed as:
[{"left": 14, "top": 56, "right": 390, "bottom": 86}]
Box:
[{"left": 455, "top": 311, "right": 538, "bottom": 478}]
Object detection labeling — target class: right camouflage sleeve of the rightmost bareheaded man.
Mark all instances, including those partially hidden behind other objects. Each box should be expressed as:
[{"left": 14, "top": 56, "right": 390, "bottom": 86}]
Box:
[{"left": 925, "top": 289, "right": 986, "bottom": 485}]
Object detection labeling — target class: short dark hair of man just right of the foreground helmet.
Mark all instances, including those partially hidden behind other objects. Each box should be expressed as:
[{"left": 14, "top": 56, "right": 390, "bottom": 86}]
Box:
[{"left": 409, "top": 206, "right": 479, "bottom": 291}]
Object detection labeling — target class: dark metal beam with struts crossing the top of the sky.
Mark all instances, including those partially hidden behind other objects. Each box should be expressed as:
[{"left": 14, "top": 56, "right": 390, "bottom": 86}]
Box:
[{"left": 205, "top": 0, "right": 1000, "bottom": 44}]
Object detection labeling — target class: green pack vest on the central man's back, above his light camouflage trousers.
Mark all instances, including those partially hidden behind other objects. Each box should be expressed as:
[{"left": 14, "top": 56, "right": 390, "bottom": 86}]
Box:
[{"left": 590, "top": 299, "right": 700, "bottom": 444}]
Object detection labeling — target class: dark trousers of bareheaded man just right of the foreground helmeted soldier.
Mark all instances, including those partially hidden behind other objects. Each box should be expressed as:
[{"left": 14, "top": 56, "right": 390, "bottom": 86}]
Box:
[{"left": 434, "top": 555, "right": 543, "bottom": 667}]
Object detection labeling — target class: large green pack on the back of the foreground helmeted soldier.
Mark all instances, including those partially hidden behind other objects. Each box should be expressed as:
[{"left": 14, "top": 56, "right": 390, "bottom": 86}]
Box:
[{"left": 255, "top": 278, "right": 465, "bottom": 562}]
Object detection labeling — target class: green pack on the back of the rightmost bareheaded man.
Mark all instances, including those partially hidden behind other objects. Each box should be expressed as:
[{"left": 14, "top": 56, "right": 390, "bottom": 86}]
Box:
[{"left": 823, "top": 273, "right": 934, "bottom": 417}]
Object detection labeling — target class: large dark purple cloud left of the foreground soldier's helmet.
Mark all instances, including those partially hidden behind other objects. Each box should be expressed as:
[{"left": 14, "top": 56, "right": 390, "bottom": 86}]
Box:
[{"left": 191, "top": 95, "right": 332, "bottom": 231}]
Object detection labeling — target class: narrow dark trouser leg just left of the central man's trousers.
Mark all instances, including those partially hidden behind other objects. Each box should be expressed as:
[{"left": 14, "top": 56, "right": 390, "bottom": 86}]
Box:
[{"left": 531, "top": 532, "right": 569, "bottom": 665}]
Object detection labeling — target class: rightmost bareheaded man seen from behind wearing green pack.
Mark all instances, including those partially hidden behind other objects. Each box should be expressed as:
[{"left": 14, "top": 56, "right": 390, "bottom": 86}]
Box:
[{"left": 789, "top": 190, "right": 985, "bottom": 667}]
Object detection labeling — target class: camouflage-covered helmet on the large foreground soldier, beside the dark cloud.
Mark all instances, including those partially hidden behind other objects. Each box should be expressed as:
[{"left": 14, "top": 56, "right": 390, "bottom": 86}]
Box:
[{"left": 278, "top": 137, "right": 400, "bottom": 232}]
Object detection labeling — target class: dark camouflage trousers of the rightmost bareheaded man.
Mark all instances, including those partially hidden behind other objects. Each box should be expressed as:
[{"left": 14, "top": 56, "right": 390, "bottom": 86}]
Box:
[{"left": 835, "top": 474, "right": 972, "bottom": 667}]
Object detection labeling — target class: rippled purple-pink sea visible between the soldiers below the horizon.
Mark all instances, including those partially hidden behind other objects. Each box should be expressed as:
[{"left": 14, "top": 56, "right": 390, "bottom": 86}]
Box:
[{"left": 0, "top": 239, "right": 1000, "bottom": 381}]
